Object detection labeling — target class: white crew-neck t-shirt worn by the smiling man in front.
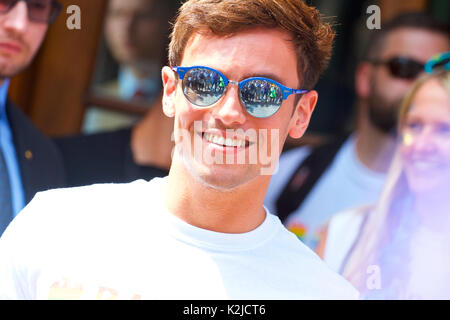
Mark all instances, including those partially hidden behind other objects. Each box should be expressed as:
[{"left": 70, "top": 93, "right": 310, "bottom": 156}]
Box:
[{"left": 0, "top": 178, "right": 358, "bottom": 299}]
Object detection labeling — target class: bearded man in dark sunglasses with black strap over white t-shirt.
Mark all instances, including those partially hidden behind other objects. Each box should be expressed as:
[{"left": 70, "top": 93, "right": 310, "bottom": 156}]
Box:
[{"left": 265, "top": 13, "right": 450, "bottom": 249}]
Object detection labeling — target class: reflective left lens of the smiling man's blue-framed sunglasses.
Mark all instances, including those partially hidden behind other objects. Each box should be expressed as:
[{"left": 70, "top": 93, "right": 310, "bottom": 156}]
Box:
[{"left": 183, "top": 68, "right": 225, "bottom": 107}]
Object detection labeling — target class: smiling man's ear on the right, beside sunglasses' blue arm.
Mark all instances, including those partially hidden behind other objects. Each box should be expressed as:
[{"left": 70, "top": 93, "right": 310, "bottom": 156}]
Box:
[{"left": 289, "top": 90, "right": 318, "bottom": 139}]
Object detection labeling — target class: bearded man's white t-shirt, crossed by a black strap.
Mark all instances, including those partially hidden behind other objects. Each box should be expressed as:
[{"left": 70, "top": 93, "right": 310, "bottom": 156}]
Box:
[{"left": 264, "top": 136, "right": 386, "bottom": 249}]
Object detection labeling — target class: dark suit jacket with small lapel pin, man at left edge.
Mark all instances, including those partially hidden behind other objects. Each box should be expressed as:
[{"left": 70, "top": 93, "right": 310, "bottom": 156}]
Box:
[{"left": 6, "top": 100, "right": 66, "bottom": 203}]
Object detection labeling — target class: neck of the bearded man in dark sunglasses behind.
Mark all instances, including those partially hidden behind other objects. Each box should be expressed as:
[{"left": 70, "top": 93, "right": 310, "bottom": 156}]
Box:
[{"left": 356, "top": 107, "right": 396, "bottom": 173}]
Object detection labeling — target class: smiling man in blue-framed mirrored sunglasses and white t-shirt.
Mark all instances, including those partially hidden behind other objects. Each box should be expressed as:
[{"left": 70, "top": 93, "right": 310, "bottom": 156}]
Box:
[{"left": 0, "top": 0, "right": 358, "bottom": 299}]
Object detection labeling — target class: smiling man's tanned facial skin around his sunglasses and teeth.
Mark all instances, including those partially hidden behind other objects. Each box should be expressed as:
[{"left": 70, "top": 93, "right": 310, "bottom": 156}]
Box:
[{"left": 172, "top": 30, "right": 298, "bottom": 191}]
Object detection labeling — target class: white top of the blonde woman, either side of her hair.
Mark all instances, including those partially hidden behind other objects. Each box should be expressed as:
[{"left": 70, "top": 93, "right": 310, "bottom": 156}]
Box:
[{"left": 324, "top": 206, "right": 450, "bottom": 300}]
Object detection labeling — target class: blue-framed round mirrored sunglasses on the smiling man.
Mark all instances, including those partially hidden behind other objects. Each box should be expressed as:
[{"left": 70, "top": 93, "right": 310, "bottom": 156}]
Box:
[{"left": 172, "top": 66, "right": 308, "bottom": 118}]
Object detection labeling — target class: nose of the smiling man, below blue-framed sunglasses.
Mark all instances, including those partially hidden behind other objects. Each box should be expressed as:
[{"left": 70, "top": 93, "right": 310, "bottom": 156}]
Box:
[{"left": 212, "top": 84, "right": 247, "bottom": 126}]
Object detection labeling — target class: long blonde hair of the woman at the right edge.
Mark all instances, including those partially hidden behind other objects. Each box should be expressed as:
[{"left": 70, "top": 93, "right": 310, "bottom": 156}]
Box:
[{"left": 342, "top": 70, "right": 450, "bottom": 296}]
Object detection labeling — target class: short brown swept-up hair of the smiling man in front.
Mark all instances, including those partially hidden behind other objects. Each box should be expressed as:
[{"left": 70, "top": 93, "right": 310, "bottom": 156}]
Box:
[{"left": 169, "top": 0, "right": 335, "bottom": 89}]
